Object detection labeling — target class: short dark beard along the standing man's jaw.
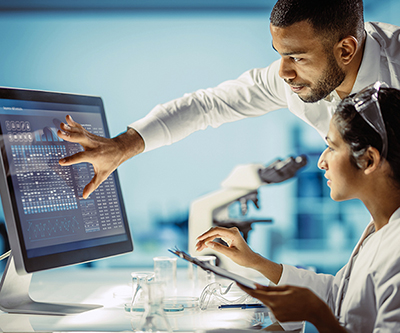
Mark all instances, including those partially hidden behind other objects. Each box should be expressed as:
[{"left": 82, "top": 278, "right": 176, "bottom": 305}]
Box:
[{"left": 286, "top": 54, "right": 346, "bottom": 103}]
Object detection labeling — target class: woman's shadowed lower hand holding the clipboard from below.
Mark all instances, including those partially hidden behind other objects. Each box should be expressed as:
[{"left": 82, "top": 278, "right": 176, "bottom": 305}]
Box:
[{"left": 239, "top": 284, "right": 346, "bottom": 333}]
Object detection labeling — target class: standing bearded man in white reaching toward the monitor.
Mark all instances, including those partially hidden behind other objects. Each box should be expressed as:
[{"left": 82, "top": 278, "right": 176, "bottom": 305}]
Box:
[{"left": 59, "top": 0, "right": 400, "bottom": 198}]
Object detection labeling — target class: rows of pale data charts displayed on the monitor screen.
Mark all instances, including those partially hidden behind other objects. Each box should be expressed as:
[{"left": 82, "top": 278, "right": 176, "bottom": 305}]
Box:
[{"left": 3, "top": 116, "right": 124, "bottom": 248}]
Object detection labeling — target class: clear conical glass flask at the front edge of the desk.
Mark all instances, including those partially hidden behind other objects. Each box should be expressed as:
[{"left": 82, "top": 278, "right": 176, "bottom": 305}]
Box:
[{"left": 135, "top": 281, "right": 172, "bottom": 333}]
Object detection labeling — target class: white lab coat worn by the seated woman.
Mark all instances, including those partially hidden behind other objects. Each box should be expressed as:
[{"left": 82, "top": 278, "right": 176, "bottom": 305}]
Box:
[{"left": 279, "top": 208, "right": 400, "bottom": 333}]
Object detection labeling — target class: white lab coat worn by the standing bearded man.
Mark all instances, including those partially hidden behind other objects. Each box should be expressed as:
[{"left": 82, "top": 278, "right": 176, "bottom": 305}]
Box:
[{"left": 129, "top": 23, "right": 400, "bottom": 151}]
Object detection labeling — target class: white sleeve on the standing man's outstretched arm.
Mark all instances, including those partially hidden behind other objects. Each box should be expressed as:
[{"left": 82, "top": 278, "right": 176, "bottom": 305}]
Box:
[{"left": 129, "top": 61, "right": 287, "bottom": 151}]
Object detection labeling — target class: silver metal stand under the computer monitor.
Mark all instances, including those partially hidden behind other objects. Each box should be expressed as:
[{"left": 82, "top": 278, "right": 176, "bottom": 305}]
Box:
[{"left": 0, "top": 252, "right": 102, "bottom": 315}]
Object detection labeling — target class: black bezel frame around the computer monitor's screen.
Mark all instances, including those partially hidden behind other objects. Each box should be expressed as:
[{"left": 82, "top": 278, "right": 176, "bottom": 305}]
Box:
[{"left": 0, "top": 87, "right": 133, "bottom": 274}]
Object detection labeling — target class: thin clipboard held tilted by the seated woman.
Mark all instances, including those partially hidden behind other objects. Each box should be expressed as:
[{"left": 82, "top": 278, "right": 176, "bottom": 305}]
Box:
[{"left": 168, "top": 248, "right": 257, "bottom": 289}]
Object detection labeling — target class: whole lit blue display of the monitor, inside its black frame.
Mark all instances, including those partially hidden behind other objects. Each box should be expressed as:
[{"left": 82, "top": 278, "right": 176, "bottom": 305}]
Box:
[{"left": 0, "top": 100, "right": 127, "bottom": 258}]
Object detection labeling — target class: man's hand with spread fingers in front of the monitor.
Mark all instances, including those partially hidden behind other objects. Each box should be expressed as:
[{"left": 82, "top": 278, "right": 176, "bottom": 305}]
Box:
[{"left": 57, "top": 115, "right": 144, "bottom": 199}]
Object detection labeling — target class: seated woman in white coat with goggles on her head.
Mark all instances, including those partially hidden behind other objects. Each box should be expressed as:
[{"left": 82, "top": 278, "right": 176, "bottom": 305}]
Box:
[{"left": 197, "top": 82, "right": 400, "bottom": 333}]
